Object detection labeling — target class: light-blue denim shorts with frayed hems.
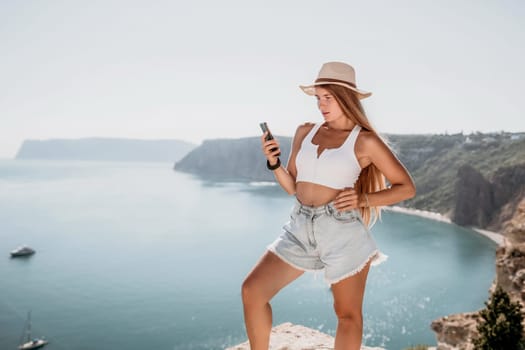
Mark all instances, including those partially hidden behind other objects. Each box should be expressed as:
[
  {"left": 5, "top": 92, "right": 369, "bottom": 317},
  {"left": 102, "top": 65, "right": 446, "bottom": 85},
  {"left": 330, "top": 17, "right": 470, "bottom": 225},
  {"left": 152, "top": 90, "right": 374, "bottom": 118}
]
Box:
[{"left": 268, "top": 202, "right": 386, "bottom": 284}]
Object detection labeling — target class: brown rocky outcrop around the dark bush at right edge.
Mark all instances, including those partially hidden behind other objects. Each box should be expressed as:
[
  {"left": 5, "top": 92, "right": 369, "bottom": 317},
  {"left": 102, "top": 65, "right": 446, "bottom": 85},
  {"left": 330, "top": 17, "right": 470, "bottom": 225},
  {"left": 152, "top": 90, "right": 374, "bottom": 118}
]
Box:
[{"left": 431, "top": 198, "right": 525, "bottom": 350}]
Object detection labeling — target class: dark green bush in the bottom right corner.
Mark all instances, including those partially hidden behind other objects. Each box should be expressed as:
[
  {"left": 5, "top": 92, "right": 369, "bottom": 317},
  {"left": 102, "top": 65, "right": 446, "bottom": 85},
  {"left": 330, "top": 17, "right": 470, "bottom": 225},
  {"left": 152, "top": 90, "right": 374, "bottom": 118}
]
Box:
[{"left": 474, "top": 288, "right": 525, "bottom": 350}]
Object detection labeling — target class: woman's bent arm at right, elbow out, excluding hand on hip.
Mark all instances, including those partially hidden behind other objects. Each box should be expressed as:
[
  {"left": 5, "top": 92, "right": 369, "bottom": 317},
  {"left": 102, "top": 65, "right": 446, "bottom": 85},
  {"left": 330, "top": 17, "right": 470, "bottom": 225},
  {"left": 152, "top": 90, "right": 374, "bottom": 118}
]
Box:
[{"left": 356, "top": 132, "right": 416, "bottom": 207}]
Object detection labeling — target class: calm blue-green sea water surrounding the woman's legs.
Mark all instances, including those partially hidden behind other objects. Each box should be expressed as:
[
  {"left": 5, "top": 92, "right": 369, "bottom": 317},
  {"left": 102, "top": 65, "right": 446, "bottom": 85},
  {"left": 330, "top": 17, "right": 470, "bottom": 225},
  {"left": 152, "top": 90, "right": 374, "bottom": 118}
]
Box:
[{"left": 0, "top": 160, "right": 495, "bottom": 350}]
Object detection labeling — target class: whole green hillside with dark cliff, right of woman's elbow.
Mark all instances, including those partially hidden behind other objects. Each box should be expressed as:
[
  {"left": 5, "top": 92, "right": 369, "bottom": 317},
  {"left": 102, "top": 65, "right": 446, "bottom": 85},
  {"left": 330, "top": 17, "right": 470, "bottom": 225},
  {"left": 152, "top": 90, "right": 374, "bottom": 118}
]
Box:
[{"left": 390, "top": 134, "right": 525, "bottom": 230}]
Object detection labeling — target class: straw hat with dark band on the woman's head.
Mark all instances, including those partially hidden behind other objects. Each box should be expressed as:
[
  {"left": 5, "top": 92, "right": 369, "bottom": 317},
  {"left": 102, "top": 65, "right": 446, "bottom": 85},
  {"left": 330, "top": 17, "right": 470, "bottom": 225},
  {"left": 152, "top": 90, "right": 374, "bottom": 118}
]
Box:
[{"left": 299, "top": 62, "right": 372, "bottom": 99}]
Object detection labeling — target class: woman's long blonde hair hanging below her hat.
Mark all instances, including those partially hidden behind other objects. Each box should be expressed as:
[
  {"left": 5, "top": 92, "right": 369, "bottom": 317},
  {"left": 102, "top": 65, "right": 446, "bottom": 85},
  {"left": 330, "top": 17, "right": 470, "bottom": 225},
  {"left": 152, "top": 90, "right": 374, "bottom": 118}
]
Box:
[{"left": 321, "top": 84, "right": 386, "bottom": 226}]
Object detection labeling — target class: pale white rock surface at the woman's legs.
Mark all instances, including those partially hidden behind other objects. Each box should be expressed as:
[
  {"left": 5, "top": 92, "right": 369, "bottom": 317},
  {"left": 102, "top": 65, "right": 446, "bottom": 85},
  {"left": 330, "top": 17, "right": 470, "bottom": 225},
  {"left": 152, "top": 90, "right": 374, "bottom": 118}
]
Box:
[{"left": 226, "top": 322, "right": 384, "bottom": 350}]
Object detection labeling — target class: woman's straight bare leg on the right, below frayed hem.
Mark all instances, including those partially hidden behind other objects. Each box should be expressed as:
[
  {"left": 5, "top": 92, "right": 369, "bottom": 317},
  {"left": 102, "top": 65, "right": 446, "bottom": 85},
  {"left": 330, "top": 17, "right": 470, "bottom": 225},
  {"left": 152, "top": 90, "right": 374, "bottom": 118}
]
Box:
[{"left": 332, "top": 262, "right": 370, "bottom": 350}]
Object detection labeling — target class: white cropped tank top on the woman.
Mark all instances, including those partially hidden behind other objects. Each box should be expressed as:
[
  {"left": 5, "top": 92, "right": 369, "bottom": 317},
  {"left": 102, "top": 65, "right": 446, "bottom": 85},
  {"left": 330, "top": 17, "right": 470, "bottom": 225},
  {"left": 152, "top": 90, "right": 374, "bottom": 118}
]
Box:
[{"left": 295, "top": 124, "right": 361, "bottom": 189}]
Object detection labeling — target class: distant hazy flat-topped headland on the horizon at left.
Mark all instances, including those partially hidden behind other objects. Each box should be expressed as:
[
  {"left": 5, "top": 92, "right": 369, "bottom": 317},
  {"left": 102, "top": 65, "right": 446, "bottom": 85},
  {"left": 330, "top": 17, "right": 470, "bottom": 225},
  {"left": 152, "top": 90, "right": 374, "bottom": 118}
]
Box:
[{"left": 15, "top": 138, "right": 195, "bottom": 162}]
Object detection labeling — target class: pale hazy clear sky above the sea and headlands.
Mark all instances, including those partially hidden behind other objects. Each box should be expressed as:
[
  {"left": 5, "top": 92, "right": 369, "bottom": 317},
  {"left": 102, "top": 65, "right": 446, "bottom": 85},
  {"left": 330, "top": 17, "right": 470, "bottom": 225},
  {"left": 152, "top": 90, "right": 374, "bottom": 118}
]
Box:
[{"left": 0, "top": 0, "right": 525, "bottom": 158}]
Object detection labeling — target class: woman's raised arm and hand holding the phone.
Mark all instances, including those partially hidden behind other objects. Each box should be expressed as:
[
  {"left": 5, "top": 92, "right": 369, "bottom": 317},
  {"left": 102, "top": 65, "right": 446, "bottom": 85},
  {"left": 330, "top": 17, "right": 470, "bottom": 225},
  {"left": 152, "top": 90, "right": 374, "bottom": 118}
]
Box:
[{"left": 261, "top": 123, "right": 313, "bottom": 194}]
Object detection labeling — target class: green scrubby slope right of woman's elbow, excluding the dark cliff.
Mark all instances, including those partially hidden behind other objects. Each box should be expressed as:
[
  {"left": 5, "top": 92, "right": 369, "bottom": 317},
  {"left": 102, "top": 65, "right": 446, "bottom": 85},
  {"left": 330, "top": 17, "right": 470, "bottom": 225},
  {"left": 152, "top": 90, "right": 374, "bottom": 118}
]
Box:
[{"left": 387, "top": 134, "right": 525, "bottom": 214}]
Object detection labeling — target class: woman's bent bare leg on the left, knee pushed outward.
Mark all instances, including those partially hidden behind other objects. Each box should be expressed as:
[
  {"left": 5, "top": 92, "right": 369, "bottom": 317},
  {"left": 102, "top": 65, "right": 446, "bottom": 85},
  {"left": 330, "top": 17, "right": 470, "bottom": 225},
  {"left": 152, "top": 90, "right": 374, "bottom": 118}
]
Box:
[{"left": 242, "top": 251, "right": 303, "bottom": 350}]
